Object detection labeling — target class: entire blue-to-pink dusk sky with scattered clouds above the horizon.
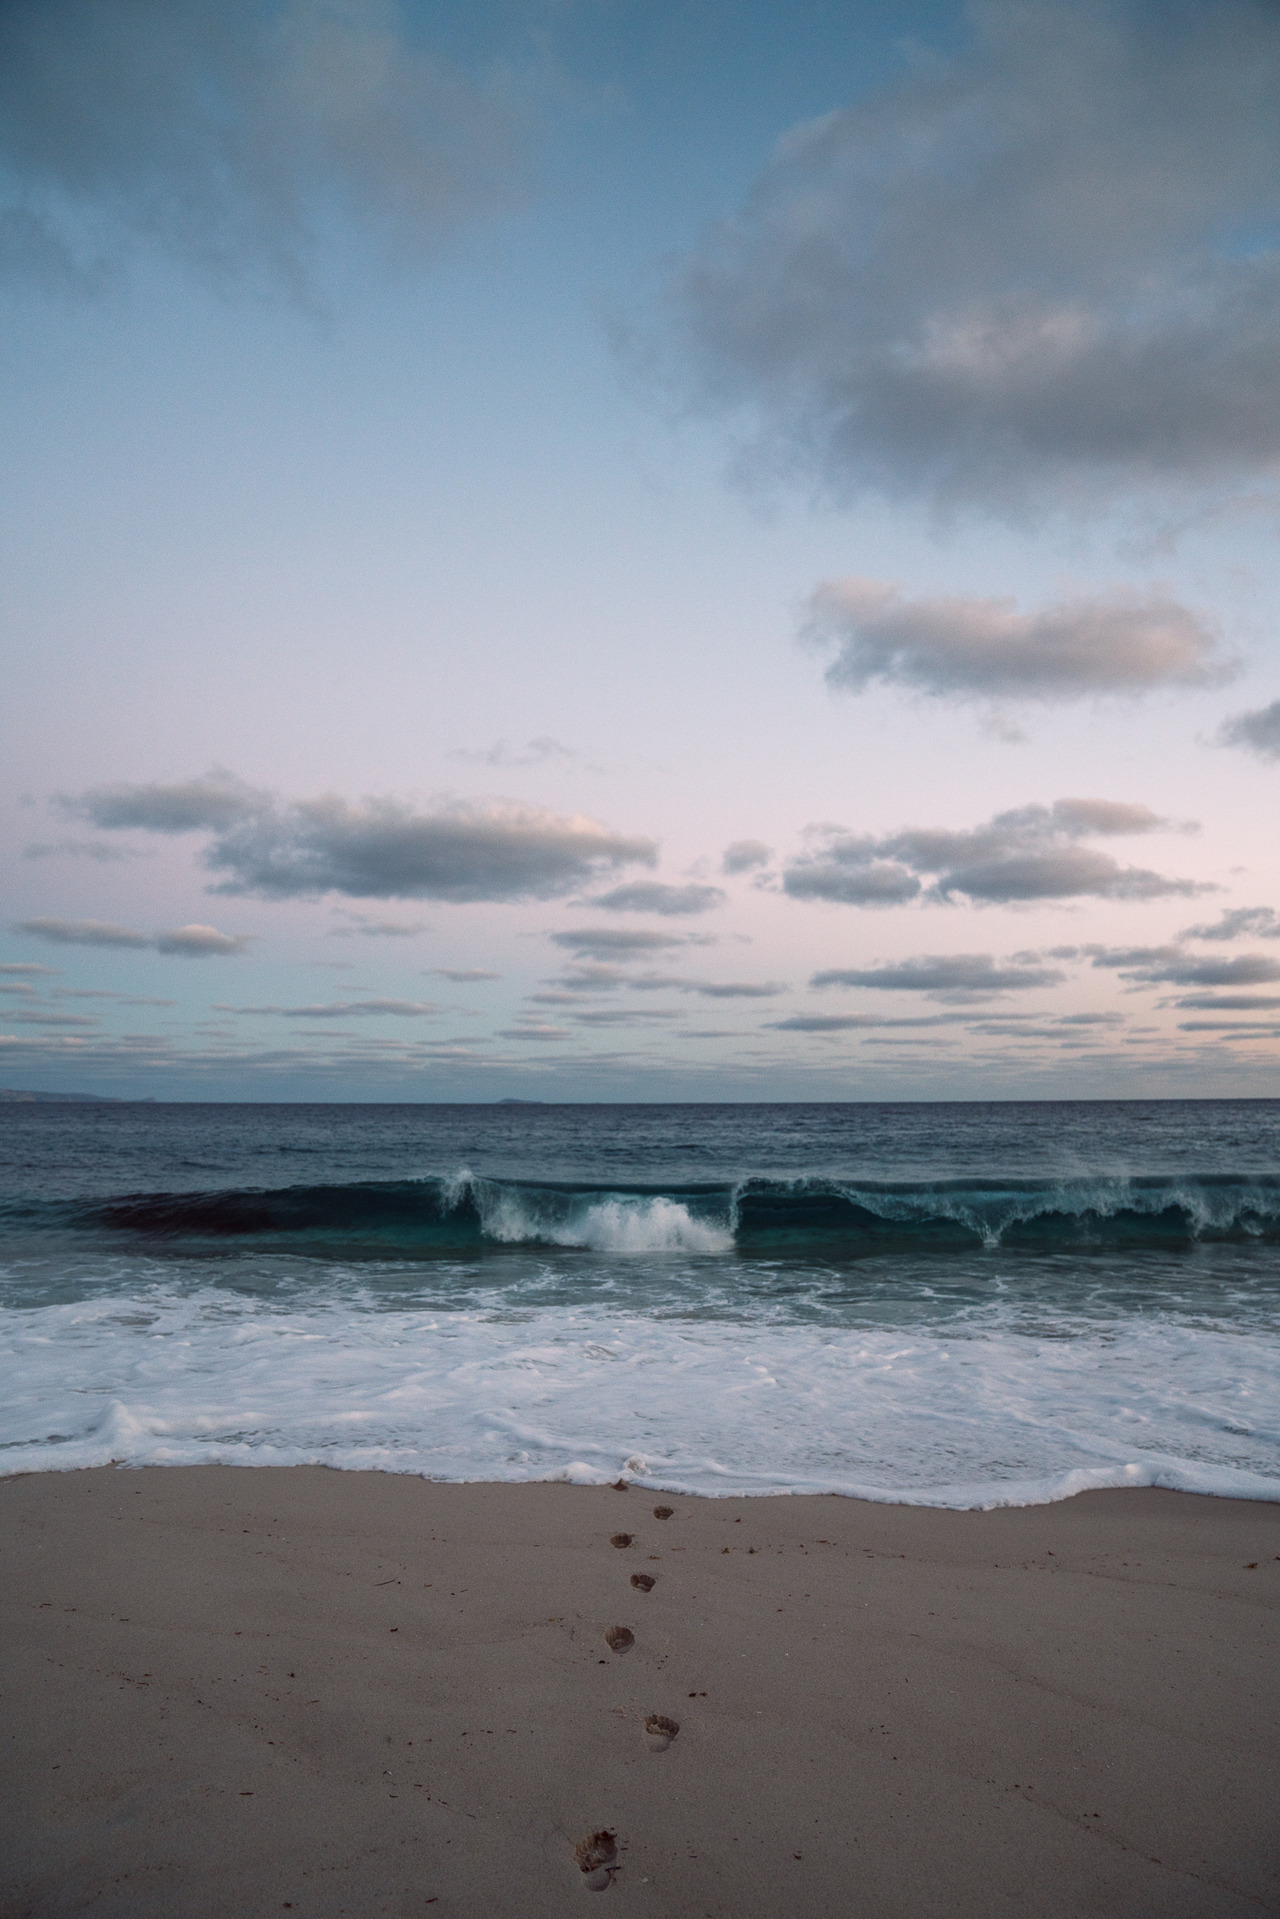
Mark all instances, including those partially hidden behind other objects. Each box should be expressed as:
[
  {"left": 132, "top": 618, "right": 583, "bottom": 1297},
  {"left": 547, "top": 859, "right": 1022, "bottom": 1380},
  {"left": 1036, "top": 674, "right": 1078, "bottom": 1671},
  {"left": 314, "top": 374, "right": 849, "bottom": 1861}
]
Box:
[{"left": 0, "top": 0, "right": 1280, "bottom": 1102}]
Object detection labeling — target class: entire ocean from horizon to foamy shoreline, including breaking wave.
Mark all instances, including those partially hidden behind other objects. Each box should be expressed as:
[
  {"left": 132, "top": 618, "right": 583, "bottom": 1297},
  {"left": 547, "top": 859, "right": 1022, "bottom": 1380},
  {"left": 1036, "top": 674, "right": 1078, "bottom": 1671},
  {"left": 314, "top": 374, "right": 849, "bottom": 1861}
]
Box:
[{"left": 0, "top": 1100, "right": 1280, "bottom": 1508}]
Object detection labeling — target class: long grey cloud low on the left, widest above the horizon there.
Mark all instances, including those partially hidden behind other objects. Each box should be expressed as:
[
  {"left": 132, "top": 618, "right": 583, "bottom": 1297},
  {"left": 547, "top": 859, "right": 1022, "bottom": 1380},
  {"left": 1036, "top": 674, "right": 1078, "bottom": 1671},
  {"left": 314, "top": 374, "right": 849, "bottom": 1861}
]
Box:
[{"left": 59, "top": 771, "right": 658, "bottom": 904}]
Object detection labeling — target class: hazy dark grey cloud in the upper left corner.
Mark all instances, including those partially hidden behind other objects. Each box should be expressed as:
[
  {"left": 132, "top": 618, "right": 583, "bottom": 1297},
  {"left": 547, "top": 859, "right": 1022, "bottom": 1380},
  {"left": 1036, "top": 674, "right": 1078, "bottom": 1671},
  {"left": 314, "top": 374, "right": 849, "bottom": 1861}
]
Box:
[{"left": 0, "top": 0, "right": 528, "bottom": 292}]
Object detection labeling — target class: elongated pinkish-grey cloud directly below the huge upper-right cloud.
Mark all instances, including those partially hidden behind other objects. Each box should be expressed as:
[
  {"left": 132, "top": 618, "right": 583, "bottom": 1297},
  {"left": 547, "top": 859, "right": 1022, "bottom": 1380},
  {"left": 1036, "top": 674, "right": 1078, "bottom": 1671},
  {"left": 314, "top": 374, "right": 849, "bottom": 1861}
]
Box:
[{"left": 802, "top": 580, "right": 1228, "bottom": 700}]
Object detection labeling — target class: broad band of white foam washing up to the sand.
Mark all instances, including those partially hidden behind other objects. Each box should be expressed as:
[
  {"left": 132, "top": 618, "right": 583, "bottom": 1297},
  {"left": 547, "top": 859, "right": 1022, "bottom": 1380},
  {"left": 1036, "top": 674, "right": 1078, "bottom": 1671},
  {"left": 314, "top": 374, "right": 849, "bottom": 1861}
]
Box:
[{"left": 0, "top": 1282, "right": 1280, "bottom": 1508}]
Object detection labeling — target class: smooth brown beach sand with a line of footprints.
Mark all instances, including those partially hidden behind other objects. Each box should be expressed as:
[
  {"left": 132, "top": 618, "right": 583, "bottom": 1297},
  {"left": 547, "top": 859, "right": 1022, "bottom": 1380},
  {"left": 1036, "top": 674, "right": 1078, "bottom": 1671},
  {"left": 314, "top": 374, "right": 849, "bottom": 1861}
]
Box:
[{"left": 0, "top": 1466, "right": 1280, "bottom": 1919}]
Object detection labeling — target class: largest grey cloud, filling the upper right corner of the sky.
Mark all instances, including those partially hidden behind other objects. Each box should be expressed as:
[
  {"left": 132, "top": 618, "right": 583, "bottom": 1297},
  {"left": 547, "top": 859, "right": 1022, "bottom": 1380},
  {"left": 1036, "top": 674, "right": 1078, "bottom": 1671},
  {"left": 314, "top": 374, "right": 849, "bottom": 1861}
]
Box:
[{"left": 672, "top": 0, "right": 1280, "bottom": 510}]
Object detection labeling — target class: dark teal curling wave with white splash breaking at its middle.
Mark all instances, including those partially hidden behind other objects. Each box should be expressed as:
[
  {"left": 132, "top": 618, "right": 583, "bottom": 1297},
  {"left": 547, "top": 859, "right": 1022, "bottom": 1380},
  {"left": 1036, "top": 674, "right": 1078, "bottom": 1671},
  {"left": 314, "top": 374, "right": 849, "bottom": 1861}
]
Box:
[{"left": 4, "top": 1174, "right": 1280, "bottom": 1261}]
